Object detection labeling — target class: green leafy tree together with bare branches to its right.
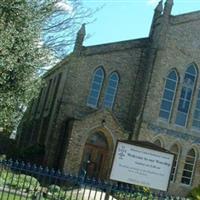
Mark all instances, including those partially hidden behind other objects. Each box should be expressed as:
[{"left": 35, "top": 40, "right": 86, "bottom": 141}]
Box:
[{"left": 0, "top": 0, "right": 90, "bottom": 132}]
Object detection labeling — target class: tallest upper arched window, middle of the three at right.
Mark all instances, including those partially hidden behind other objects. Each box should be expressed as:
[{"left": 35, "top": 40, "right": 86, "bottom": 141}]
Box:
[{"left": 175, "top": 64, "right": 197, "bottom": 126}]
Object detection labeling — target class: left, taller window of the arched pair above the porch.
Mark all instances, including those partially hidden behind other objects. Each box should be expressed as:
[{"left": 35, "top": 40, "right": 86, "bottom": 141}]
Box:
[{"left": 87, "top": 67, "right": 104, "bottom": 108}]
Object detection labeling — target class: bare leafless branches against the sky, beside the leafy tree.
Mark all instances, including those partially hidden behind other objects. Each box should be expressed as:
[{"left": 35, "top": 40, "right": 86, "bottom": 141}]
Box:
[{"left": 43, "top": 0, "right": 91, "bottom": 59}]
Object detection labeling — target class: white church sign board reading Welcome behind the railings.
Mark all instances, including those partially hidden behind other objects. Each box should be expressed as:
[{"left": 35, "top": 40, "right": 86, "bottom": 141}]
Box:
[{"left": 110, "top": 142, "right": 174, "bottom": 191}]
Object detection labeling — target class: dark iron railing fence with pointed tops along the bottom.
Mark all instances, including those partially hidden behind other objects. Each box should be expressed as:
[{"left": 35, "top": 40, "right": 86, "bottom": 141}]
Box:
[{"left": 0, "top": 160, "right": 185, "bottom": 200}]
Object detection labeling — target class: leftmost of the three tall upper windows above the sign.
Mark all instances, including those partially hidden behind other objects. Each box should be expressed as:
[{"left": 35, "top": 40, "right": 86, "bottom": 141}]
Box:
[{"left": 159, "top": 70, "right": 178, "bottom": 121}]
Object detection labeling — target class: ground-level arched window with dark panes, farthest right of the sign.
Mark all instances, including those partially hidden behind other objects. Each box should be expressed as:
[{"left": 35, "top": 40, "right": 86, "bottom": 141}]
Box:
[{"left": 181, "top": 149, "right": 196, "bottom": 185}]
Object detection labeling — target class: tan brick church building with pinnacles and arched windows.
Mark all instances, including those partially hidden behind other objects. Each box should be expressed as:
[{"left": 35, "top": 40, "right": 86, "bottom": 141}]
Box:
[{"left": 18, "top": 0, "right": 200, "bottom": 195}]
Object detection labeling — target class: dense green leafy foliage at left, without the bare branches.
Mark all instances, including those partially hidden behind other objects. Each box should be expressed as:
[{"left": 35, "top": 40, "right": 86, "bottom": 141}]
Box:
[{"left": 0, "top": 0, "right": 50, "bottom": 134}]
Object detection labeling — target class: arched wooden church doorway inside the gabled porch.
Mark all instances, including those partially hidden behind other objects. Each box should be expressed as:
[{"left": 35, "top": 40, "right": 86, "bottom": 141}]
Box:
[{"left": 81, "top": 132, "right": 109, "bottom": 179}]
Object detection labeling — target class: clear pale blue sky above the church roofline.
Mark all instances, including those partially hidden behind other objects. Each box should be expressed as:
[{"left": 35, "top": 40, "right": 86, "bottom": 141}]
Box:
[{"left": 83, "top": 0, "right": 200, "bottom": 46}]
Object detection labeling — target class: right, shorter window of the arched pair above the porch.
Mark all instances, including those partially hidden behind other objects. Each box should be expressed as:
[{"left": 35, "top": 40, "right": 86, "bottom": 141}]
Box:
[{"left": 103, "top": 72, "right": 119, "bottom": 108}]
